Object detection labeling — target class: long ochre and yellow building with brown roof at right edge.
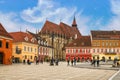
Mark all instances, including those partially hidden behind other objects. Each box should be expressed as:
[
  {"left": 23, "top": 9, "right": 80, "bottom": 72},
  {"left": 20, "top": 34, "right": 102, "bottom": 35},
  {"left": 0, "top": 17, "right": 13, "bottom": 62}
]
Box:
[{"left": 91, "top": 31, "right": 120, "bottom": 61}]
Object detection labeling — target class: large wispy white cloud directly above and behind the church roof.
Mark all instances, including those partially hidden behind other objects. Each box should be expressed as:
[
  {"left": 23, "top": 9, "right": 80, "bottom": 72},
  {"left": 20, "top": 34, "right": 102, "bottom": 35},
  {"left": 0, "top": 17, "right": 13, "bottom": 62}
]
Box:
[{"left": 21, "top": 0, "right": 89, "bottom": 34}]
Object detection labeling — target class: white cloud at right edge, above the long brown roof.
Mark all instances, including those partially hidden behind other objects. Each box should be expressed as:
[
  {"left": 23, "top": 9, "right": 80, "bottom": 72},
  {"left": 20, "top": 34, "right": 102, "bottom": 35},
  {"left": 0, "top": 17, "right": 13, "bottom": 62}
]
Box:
[{"left": 107, "top": 0, "right": 120, "bottom": 30}]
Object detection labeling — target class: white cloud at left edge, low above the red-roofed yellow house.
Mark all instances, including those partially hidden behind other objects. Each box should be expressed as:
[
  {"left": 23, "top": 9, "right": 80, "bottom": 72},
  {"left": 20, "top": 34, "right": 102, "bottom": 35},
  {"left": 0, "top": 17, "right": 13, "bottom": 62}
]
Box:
[{"left": 0, "top": 12, "right": 36, "bottom": 32}]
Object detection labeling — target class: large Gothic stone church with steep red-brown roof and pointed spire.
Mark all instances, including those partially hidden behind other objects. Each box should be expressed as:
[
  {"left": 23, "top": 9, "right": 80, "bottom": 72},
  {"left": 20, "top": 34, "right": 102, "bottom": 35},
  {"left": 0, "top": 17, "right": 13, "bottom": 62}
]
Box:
[{"left": 39, "top": 18, "right": 81, "bottom": 60}]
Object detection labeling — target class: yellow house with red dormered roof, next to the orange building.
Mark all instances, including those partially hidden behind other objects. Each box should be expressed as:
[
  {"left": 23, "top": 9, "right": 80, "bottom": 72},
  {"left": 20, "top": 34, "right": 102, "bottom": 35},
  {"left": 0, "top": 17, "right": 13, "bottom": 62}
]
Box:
[{"left": 10, "top": 32, "right": 38, "bottom": 63}]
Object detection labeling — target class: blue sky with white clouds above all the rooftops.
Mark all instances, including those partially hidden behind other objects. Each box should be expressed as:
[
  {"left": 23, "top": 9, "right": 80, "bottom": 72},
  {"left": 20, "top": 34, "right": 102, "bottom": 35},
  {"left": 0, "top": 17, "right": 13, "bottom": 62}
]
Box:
[{"left": 0, "top": 0, "right": 120, "bottom": 35}]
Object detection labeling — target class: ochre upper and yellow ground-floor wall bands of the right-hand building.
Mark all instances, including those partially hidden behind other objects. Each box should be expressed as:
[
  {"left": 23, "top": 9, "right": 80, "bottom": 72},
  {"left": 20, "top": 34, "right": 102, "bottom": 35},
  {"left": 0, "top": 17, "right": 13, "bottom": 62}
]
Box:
[{"left": 92, "top": 40, "right": 120, "bottom": 60}]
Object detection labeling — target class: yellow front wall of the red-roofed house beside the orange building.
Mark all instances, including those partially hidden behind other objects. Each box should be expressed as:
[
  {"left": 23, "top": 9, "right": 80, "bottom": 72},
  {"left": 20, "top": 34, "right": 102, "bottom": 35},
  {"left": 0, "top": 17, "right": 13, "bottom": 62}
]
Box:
[{"left": 12, "top": 42, "right": 38, "bottom": 62}]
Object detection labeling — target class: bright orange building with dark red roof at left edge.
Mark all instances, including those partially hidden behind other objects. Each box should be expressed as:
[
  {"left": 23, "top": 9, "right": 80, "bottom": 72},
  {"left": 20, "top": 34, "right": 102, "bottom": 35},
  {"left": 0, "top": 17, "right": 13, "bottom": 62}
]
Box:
[{"left": 0, "top": 24, "right": 12, "bottom": 64}]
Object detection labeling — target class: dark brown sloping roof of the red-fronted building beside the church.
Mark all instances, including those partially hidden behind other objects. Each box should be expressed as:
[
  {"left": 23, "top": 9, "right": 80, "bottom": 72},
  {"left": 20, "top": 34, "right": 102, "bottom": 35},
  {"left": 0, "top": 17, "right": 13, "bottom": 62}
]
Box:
[{"left": 66, "top": 36, "right": 91, "bottom": 47}]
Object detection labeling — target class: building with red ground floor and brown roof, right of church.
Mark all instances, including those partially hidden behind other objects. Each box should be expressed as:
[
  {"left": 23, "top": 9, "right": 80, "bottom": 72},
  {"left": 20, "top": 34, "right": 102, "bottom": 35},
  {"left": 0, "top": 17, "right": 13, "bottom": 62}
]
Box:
[{"left": 66, "top": 36, "right": 91, "bottom": 61}]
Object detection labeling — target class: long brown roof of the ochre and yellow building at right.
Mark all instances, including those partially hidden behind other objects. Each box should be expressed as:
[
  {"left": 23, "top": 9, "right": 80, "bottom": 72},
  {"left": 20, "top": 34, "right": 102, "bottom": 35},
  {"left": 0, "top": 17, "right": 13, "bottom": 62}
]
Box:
[{"left": 91, "top": 30, "right": 120, "bottom": 40}]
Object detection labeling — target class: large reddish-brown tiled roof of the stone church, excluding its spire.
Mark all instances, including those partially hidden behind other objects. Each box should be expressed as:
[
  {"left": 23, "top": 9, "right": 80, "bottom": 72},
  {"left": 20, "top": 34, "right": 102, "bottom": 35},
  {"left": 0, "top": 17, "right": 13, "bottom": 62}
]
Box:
[{"left": 41, "top": 20, "right": 81, "bottom": 38}]
